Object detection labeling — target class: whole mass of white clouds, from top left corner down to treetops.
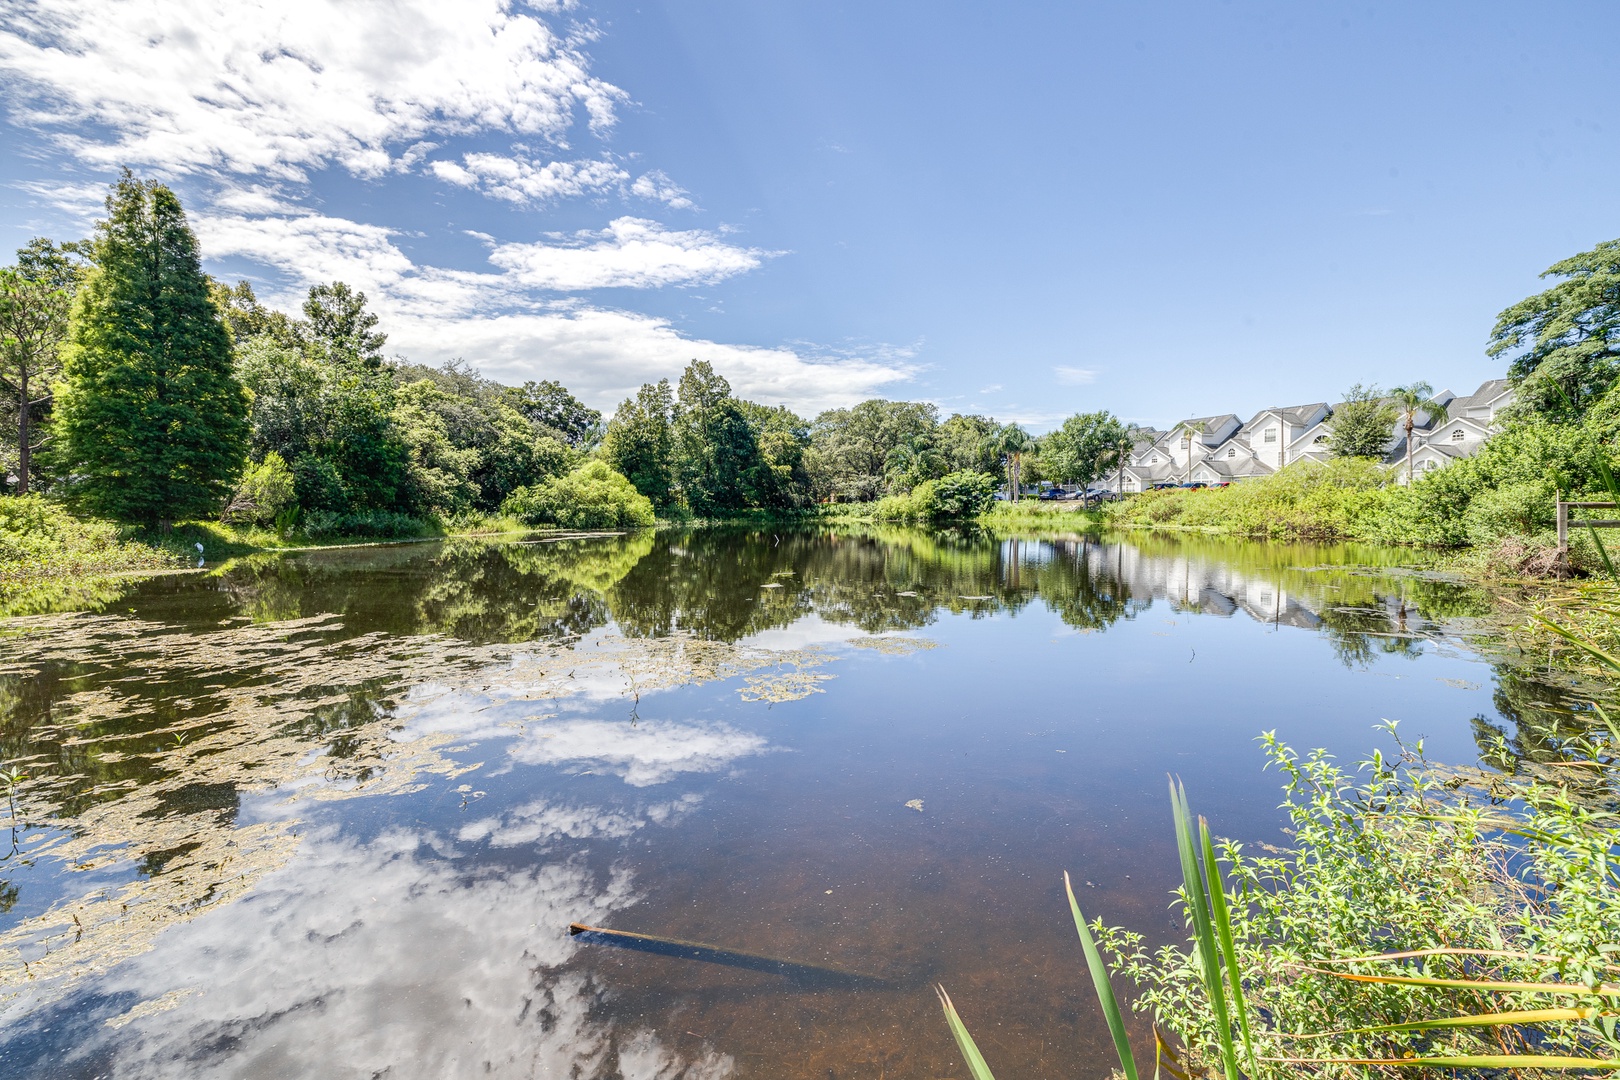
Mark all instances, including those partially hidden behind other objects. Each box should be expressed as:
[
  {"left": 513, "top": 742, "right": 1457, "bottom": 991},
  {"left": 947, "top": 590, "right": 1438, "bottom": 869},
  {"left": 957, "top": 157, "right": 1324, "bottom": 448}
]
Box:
[{"left": 0, "top": 0, "right": 919, "bottom": 413}]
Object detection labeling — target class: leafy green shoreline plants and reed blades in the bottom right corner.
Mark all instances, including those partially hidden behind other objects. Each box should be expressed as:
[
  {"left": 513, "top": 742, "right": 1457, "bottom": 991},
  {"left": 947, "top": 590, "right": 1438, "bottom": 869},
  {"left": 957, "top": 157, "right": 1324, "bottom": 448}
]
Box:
[{"left": 941, "top": 730, "right": 1620, "bottom": 1080}]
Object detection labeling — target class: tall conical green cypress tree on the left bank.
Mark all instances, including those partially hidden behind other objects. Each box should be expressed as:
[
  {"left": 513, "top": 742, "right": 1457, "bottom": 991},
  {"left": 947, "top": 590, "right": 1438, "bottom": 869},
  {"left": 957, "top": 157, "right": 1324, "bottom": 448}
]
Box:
[{"left": 57, "top": 170, "right": 248, "bottom": 526}]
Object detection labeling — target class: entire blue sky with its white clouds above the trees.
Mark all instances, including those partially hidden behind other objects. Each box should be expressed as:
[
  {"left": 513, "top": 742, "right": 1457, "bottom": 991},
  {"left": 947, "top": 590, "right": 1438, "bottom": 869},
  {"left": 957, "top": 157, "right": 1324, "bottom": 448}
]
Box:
[{"left": 0, "top": 0, "right": 1620, "bottom": 429}]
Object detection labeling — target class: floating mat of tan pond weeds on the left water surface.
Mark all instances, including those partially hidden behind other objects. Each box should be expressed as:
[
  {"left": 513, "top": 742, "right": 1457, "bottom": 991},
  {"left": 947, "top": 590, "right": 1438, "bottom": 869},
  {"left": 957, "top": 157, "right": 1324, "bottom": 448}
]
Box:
[{"left": 0, "top": 614, "right": 833, "bottom": 1007}]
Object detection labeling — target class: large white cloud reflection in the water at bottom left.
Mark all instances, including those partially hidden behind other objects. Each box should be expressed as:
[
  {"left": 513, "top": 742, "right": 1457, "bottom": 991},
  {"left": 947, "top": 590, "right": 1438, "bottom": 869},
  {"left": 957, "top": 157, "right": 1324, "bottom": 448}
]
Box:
[{"left": 58, "top": 831, "right": 735, "bottom": 1080}]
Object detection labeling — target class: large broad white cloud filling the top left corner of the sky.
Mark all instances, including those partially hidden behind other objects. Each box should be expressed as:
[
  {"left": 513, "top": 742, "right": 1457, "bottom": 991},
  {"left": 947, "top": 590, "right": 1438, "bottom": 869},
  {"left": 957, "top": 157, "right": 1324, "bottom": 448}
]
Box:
[{"left": 0, "top": 0, "right": 625, "bottom": 178}]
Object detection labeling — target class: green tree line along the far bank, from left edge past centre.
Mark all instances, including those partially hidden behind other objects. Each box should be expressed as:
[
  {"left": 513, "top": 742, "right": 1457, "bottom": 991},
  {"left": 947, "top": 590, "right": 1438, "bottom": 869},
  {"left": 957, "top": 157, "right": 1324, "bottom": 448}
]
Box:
[{"left": 0, "top": 172, "right": 1153, "bottom": 533}]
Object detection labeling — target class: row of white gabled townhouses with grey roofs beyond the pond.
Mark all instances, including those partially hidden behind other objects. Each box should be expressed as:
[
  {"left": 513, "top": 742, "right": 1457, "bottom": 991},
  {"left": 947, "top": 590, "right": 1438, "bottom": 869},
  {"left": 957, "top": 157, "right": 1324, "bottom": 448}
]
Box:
[{"left": 1098, "top": 379, "right": 1513, "bottom": 492}]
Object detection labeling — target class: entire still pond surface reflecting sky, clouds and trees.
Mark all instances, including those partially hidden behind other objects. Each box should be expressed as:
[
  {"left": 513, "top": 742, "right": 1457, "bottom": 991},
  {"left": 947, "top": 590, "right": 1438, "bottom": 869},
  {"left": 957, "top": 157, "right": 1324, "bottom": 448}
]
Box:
[{"left": 0, "top": 531, "right": 1565, "bottom": 1080}]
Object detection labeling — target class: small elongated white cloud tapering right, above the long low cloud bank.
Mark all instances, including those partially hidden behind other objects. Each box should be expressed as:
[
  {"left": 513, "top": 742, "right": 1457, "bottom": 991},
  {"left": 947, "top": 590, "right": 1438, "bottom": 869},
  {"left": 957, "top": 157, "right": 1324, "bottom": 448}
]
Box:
[{"left": 489, "top": 217, "right": 774, "bottom": 291}]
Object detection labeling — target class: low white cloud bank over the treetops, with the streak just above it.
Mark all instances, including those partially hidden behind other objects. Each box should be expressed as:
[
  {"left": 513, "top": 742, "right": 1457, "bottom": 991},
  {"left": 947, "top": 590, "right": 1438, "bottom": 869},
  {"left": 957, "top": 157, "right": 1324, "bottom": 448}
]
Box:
[{"left": 193, "top": 207, "right": 917, "bottom": 416}]
